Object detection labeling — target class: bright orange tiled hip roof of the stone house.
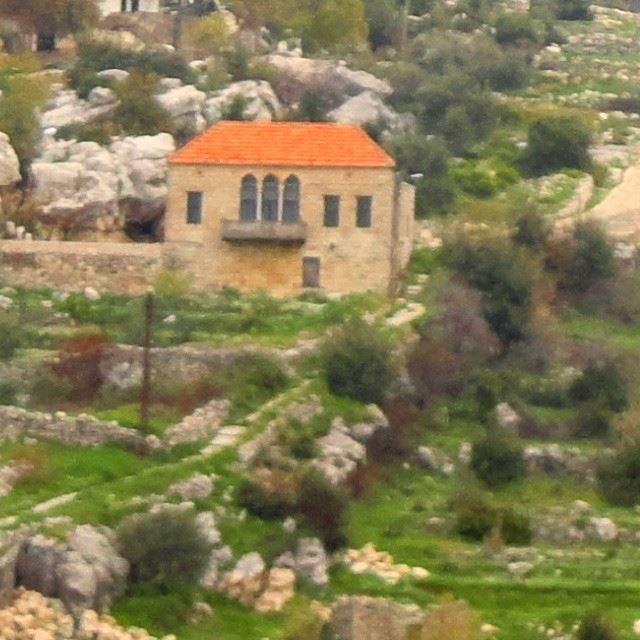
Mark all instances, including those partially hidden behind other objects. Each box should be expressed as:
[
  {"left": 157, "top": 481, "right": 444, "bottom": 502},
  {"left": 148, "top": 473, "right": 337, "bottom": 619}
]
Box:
[{"left": 169, "top": 121, "right": 395, "bottom": 167}]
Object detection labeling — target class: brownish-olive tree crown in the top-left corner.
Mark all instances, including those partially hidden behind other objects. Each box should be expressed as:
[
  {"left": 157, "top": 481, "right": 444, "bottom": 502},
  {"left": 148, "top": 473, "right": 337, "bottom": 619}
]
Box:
[{"left": 0, "top": 0, "right": 100, "bottom": 48}]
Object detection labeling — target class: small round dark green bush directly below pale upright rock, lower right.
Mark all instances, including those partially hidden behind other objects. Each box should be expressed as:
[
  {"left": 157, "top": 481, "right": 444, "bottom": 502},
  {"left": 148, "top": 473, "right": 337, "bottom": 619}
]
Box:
[{"left": 471, "top": 431, "right": 525, "bottom": 487}]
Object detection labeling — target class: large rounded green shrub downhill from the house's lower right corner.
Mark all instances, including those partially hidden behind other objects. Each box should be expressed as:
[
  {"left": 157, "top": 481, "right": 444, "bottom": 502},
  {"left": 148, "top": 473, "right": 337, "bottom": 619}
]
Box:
[{"left": 321, "top": 320, "right": 394, "bottom": 404}]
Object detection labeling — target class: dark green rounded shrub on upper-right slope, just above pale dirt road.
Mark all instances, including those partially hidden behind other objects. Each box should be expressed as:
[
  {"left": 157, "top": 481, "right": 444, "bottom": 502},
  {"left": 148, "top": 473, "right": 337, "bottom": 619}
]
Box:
[{"left": 522, "top": 116, "right": 592, "bottom": 175}]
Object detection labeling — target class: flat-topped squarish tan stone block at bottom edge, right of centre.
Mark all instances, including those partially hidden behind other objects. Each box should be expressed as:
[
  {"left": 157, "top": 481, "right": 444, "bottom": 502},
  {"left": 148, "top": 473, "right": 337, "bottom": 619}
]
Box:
[{"left": 331, "top": 596, "right": 424, "bottom": 640}]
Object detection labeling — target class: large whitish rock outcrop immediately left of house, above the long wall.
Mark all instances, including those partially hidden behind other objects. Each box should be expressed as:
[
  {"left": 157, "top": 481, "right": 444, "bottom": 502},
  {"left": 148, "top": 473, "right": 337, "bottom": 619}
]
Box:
[{"left": 31, "top": 133, "right": 175, "bottom": 235}]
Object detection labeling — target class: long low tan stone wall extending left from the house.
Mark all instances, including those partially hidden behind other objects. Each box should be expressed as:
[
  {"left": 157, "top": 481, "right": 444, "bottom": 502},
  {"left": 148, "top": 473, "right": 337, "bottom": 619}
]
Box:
[{"left": 0, "top": 240, "right": 163, "bottom": 295}]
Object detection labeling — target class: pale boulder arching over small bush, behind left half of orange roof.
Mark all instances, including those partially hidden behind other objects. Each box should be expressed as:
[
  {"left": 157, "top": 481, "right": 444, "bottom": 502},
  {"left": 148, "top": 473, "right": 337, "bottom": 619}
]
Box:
[{"left": 204, "top": 80, "right": 283, "bottom": 123}]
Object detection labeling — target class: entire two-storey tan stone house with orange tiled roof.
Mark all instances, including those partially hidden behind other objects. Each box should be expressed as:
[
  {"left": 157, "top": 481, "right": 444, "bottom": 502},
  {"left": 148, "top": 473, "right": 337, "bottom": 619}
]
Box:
[{"left": 165, "top": 122, "right": 415, "bottom": 294}]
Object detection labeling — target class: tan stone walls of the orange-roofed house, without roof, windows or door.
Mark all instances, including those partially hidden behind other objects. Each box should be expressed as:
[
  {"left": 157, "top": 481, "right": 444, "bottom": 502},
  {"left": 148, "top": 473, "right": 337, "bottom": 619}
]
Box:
[{"left": 165, "top": 165, "right": 413, "bottom": 294}]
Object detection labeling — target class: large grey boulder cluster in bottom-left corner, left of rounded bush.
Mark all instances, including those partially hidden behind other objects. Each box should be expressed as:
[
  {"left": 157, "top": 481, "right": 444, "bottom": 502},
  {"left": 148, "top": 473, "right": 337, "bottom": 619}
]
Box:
[{"left": 16, "top": 525, "right": 129, "bottom": 618}]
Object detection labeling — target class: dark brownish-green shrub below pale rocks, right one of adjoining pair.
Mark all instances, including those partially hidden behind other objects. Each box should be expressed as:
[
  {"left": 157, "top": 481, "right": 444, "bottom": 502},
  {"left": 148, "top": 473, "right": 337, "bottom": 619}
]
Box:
[{"left": 298, "top": 469, "right": 349, "bottom": 550}]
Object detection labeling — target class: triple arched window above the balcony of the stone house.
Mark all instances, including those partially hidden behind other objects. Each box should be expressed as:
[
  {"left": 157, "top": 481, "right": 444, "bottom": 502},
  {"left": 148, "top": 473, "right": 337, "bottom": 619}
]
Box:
[{"left": 240, "top": 174, "right": 300, "bottom": 223}]
